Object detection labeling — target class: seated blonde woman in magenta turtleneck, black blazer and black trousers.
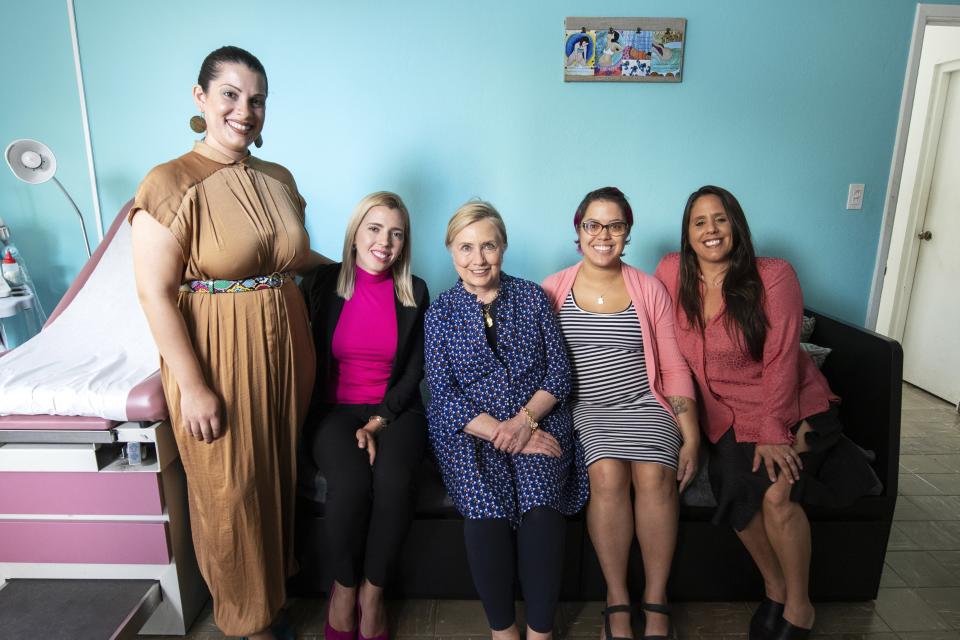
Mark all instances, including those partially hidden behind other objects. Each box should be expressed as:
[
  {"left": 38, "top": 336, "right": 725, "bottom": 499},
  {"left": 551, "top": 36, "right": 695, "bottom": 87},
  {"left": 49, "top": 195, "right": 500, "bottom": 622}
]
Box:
[{"left": 301, "top": 191, "right": 430, "bottom": 640}]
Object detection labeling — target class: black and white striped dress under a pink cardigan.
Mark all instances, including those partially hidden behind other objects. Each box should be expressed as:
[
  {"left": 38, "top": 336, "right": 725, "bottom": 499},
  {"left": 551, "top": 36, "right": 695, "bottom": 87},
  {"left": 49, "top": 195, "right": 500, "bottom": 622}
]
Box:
[{"left": 560, "top": 291, "right": 683, "bottom": 469}]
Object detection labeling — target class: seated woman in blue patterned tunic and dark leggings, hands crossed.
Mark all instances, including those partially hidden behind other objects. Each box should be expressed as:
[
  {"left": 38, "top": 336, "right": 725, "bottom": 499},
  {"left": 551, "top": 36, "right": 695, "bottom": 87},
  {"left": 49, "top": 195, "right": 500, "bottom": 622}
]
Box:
[{"left": 424, "top": 201, "right": 587, "bottom": 640}]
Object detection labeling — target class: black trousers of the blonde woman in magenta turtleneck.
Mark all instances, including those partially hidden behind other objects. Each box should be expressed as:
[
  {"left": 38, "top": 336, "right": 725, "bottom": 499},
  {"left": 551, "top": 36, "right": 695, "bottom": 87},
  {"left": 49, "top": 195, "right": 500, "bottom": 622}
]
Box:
[{"left": 313, "top": 404, "right": 427, "bottom": 587}]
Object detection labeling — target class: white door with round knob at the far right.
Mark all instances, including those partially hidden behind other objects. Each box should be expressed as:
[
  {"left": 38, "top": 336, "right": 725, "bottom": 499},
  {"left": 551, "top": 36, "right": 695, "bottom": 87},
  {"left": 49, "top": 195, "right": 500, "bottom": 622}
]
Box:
[{"left": 903, "top": 64, "right": 960, "bottom": 404}]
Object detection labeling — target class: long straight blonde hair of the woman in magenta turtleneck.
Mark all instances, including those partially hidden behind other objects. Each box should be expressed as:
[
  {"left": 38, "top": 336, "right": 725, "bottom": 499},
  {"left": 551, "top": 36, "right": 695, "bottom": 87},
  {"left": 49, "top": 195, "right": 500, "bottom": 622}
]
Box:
[{"left": 337, "top": 191, "right": 417, "bottom": 307}]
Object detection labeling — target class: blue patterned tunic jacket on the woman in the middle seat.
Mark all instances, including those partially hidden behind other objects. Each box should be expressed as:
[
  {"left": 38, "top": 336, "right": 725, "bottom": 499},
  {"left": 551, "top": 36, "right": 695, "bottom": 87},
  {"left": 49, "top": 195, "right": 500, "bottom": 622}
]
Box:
[{"left": 424, "top": 274, "right": 588, "bottom": 525}]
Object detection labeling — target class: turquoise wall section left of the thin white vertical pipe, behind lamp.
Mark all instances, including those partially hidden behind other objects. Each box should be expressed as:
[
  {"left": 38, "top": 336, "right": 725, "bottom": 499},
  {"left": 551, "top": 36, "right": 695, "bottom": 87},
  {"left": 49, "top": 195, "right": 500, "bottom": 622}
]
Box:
[{"left": 0, "top": 0, "right": 97, "bottom": 320}]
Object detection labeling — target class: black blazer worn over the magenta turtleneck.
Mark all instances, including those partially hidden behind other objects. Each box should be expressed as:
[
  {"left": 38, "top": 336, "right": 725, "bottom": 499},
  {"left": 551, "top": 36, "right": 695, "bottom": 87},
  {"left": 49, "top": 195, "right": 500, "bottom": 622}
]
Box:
[{"left": 300, "top": 263, "right": 430, "bottom": 420}]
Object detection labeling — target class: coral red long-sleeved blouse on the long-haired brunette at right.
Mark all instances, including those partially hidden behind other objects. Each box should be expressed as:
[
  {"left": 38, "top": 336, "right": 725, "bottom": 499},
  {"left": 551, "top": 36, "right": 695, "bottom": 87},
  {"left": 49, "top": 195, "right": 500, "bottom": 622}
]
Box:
[{"left": 656, "top": 253, "right": 839, "bottom": 444}]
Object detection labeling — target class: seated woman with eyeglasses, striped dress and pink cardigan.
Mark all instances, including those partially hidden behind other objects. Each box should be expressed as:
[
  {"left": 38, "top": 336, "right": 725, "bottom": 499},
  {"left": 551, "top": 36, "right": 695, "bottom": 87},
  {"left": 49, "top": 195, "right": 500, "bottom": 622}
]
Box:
[{"left": 543, "top": 187, "right": 700, "bottom": 640}]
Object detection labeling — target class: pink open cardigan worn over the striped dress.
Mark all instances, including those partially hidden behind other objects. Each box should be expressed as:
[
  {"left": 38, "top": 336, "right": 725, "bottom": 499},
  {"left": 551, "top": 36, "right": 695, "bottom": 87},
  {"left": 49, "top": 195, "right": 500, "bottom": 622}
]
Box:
[{"left": 543, "top": 262, "right": 697, "bottom": 415}]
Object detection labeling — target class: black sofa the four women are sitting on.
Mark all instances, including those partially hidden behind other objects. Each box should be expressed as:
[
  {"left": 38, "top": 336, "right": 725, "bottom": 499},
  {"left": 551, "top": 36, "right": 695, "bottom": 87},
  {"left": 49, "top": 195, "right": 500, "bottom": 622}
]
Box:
[{"left": 290, "top": 309, "right": 903, "bottom": 601}]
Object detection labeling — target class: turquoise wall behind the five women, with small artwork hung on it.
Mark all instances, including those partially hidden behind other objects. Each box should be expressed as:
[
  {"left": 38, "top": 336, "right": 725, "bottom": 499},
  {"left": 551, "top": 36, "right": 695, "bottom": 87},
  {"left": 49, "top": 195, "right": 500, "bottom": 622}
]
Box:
[{"left": 0, "top": 0, "right": 956, "bottom": 330}]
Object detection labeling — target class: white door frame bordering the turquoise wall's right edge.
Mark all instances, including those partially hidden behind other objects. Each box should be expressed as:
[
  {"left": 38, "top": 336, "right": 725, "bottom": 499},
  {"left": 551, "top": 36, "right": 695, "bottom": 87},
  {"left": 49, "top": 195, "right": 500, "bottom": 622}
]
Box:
[{"left": 866, "top": 4, "right": 960, "bottom": 332}]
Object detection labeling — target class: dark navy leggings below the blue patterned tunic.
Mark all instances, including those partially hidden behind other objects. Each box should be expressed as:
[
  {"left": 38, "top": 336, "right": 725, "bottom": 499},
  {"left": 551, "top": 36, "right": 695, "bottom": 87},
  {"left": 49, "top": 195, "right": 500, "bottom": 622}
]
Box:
[{"left": 463, "top": 507, "right": 566, "bottom": 633}]
